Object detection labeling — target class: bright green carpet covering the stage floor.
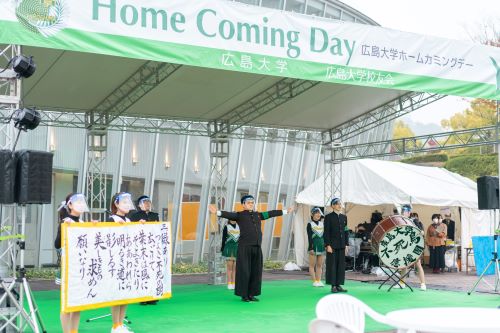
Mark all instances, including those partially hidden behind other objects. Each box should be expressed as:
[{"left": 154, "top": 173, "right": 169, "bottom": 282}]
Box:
[{"left": 35, "top": 280, "right": 500, "bottom": 333}]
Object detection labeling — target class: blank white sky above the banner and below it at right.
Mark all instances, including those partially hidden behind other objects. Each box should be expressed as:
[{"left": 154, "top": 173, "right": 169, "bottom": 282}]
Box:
[{"left": 340, "top": 0, "right": 500, "bottom": 134}]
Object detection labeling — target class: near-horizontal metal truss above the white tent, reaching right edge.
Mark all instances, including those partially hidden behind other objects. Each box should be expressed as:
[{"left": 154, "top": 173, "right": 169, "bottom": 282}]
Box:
[{"left": 331, "top": 126, "right": 497, "bottom": 163}]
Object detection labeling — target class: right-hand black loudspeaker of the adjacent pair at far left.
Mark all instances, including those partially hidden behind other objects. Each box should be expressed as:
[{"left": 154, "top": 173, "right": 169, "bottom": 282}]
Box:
[{"left": 14, "top": 150, "right": 54, "bottom": 204}]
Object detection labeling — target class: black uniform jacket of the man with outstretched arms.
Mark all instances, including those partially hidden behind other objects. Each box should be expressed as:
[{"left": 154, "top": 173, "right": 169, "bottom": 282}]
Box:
[{"left": 221, "top": 210, "right": 283, "bottom": 246}]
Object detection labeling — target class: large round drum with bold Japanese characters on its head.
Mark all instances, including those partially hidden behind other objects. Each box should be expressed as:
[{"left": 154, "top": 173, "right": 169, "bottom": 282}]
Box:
[{"left": 372, "top": 215, "right": 425, "bottom": 269}]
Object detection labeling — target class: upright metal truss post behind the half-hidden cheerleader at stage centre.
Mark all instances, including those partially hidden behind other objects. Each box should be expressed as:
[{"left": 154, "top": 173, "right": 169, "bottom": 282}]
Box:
[{"left": 208, "top": 123, "right": 229, "bottom": 284}]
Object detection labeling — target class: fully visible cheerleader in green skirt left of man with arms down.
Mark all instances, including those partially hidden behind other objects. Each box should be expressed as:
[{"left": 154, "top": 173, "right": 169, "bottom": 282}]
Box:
[{"left": 307, "top": 207, "right": 325, "bottom": 287}]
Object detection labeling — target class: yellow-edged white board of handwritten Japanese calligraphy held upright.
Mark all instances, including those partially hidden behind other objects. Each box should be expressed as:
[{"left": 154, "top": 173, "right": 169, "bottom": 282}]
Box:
[{"left": 61, "top": 222, "right": 172, "bottom": 312}]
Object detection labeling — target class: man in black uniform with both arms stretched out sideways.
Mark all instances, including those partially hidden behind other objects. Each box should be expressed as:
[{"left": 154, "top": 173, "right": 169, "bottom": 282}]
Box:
[{"left": 209, "top": 195, "right": 292, "bottom": 302}]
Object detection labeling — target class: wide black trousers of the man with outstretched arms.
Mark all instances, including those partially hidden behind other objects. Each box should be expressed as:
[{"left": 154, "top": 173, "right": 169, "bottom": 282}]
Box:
[{"left": 234, "top": 245, "right": 263, "bottom": 297}]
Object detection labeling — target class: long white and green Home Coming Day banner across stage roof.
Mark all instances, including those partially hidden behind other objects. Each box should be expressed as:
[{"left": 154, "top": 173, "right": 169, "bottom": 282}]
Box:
[{"left": 0, "top": 0, "right": 500, "bottom": 99}]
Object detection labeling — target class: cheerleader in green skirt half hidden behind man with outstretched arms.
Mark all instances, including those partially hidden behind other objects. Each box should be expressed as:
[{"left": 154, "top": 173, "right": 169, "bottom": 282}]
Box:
[{"left": 221, "top": 221, "right": 240, "bottom": 290}]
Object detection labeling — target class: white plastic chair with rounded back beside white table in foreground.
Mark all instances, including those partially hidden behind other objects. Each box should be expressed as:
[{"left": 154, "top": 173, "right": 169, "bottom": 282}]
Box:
[{"left": 316, "top": 294, "right": 390, "bottom": 333}]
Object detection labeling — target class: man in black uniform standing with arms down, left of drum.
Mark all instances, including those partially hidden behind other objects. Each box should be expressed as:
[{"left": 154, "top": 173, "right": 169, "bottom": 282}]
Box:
[{"left": 323, "top": 198, "right": 349, "bottom": 293}]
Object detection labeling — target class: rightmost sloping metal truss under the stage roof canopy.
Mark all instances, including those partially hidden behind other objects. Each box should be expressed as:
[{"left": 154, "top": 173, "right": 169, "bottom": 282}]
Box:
[{"left": 323, "top": 92, "right": 446, "bottom": 144}]
